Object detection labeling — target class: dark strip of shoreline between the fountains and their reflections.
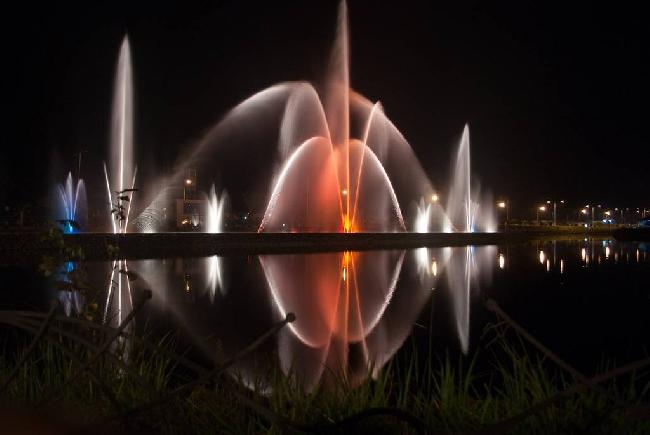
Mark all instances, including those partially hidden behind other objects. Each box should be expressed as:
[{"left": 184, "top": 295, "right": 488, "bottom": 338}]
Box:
[{"left": 0, "top": 227, "right": 615, "bottom": 264}]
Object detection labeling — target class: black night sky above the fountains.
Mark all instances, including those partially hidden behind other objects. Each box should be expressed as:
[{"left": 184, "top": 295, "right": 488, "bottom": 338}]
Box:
[{"left": 0, "top": 0, "right": 650, "bottom": 218}]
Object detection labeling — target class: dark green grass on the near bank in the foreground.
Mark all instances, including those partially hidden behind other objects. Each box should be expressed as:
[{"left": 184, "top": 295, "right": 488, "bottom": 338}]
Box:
[{"left": 0, "top": 314, "right": 650, "bottom": 435}]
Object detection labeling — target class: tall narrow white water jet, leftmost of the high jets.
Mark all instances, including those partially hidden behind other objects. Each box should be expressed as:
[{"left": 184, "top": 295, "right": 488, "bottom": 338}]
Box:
[{"left": 104, "top": 36, "right": 136, "bottom": 233}]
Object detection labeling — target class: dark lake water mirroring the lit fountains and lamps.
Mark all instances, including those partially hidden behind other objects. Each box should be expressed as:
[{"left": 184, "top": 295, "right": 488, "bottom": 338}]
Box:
[{"left": 0, "top": 239, "right": 650, "bottom": 385}]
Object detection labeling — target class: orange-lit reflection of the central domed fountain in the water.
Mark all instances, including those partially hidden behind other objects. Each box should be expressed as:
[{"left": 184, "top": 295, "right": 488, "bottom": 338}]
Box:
[{"left": 260, "top": 251, "right": 404, "bottom": 388}]
